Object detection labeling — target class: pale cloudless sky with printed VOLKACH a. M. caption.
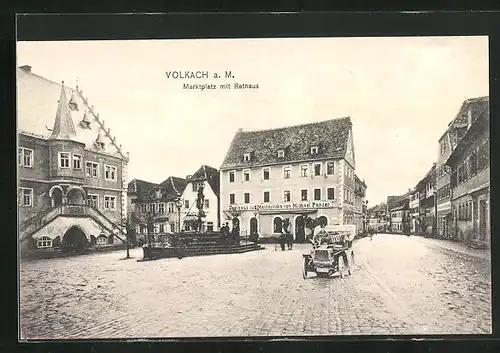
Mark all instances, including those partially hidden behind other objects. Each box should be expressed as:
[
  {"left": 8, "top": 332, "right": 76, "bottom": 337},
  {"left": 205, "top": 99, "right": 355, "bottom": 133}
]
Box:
[{"left": 17, "top": 37, "right": 489, "bottom": 207}]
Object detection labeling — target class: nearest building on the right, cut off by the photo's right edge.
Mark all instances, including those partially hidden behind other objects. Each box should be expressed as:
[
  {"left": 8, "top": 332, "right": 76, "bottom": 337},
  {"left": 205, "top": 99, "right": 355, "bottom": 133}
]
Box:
[{"left": 446, "top": 98, "right": 491, "bottom": 247}]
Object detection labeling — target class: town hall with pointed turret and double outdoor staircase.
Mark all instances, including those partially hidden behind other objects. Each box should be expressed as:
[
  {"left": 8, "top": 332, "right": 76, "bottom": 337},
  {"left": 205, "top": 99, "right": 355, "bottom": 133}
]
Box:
[{"left": 17, "top": 66, "right": 129, "bottom": 251}]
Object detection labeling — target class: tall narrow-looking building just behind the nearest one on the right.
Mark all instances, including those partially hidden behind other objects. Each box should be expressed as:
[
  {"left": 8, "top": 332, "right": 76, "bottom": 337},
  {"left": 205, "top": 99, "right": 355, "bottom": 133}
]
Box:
[{"left": 436, "top": 97, "right": 488, "bottom": 238}]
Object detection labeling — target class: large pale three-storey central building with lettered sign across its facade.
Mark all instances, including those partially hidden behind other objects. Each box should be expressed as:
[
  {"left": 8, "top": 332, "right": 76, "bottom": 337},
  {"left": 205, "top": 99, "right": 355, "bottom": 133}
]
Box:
[{"left": 220, "top": 117, "right": 364, "bottom": 241}]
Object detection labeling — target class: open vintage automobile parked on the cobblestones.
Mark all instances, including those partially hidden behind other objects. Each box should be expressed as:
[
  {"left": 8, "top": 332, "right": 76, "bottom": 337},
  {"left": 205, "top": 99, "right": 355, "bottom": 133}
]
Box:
[{"left": 302, "top": 226, "right": 354, "bottom": 279}]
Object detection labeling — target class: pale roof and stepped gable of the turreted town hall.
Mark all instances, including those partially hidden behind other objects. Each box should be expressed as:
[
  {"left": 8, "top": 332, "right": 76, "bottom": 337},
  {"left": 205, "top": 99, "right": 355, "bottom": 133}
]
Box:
[{"left": 16, "top": 67, "right": 128, "bottom": 158}]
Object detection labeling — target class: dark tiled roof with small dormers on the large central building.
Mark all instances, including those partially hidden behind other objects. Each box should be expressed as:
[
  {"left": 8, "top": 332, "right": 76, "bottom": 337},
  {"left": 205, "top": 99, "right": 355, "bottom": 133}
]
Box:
[{"left": 221, "top": 117, "right": 352, "bottom": 169}]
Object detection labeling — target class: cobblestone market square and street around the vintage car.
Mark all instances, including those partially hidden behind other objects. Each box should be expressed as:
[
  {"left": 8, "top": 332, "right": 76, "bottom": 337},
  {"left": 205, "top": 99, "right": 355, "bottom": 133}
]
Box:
[{"left": 20, "top": 235, "right": 491, "bottom": 339}]
